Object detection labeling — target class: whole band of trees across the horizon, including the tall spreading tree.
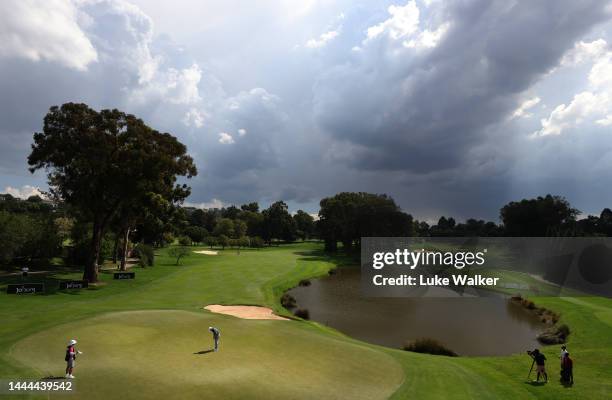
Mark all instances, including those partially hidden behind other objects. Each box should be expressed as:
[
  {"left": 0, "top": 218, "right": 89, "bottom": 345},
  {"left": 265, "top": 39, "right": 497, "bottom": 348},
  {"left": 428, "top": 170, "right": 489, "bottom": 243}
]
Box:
[{"left": 0, "top": 103, "right": 612, "bottom": 282}]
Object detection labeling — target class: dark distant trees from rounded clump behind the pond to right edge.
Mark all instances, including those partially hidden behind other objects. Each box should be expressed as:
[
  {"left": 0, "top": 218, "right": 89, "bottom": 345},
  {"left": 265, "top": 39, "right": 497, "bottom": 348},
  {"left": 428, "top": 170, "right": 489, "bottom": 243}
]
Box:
[{"left": 317, "top": 193, "right": 612, "bottom": 251}]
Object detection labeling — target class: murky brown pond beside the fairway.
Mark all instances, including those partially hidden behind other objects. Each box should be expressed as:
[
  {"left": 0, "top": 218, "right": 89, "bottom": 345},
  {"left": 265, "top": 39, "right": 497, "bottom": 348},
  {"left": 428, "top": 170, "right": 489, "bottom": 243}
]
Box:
[{"left": 288, "top": 268, "right": 545, "bottom": 356}]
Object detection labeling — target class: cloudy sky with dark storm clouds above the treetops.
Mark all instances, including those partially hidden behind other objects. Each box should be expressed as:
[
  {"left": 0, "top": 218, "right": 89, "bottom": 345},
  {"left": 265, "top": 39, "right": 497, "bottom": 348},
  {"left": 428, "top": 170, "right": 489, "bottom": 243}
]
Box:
[{"left": 0, "top": 0, "right": 612, "bottom": 221}]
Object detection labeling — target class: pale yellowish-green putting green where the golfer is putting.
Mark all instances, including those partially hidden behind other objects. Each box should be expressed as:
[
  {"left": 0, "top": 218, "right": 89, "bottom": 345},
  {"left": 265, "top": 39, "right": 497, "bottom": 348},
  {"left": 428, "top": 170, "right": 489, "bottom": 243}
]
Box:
[{"left": 10, "top": 310, "right": 403, "bottom": 399}]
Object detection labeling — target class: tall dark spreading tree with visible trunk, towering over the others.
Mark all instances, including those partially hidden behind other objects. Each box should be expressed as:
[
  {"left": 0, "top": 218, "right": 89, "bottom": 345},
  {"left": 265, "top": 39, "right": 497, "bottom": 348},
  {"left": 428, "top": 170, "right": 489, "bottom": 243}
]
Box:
[{"left": 28, "top": 103, "right": 197, "bottom": 282}]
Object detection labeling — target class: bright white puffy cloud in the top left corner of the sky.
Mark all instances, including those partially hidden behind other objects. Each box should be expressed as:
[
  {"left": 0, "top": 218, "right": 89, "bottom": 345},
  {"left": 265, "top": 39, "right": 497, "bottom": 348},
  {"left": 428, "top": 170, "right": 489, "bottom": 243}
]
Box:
[{"left": 0, "top": 0, "right": 98, "bottom": 70}]
